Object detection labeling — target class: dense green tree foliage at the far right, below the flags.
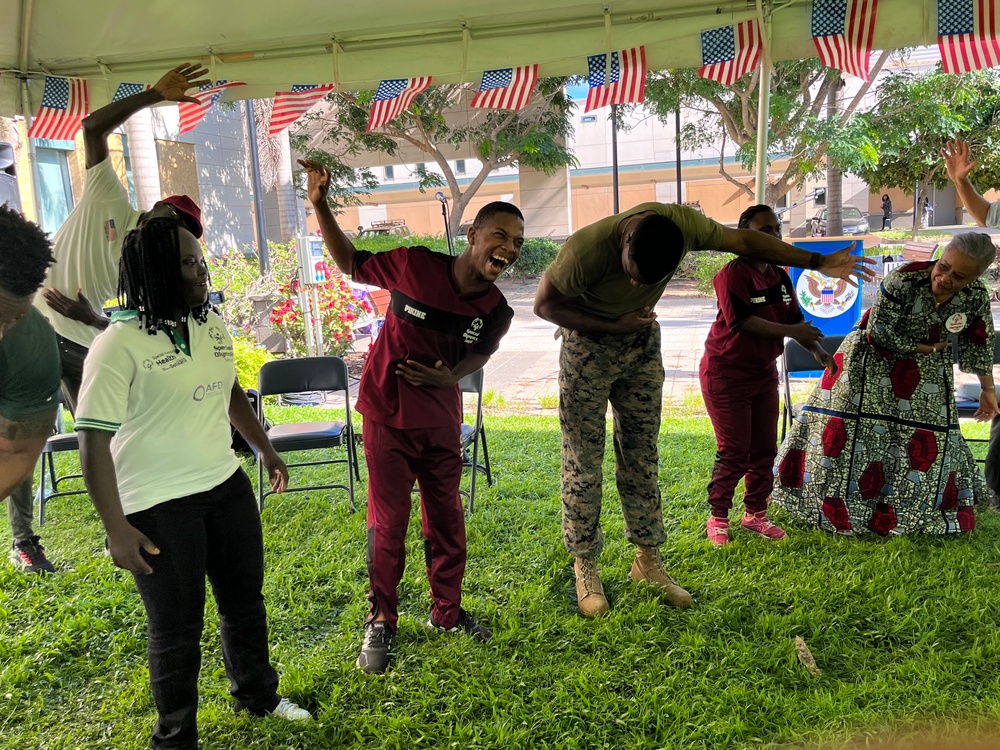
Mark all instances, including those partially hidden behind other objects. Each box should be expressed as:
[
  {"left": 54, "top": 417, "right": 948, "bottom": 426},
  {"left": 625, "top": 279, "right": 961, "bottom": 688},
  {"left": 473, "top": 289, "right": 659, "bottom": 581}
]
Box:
[{"left": 831, "top": 68, "right": 1000, "bottom": 217}]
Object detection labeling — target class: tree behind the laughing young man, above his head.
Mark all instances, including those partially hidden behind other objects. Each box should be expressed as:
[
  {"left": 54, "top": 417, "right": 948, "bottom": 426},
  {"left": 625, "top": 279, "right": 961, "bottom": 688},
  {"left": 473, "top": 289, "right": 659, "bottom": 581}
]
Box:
[{"left": 293, "top": 78, "right": 576, "bottom": 228}]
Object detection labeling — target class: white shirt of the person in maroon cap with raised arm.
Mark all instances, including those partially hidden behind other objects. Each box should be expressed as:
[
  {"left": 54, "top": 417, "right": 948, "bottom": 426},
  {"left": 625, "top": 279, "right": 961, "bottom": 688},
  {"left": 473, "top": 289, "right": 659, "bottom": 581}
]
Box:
[{"left": 35, "top": 162, "right": 142, "bottom": 347}]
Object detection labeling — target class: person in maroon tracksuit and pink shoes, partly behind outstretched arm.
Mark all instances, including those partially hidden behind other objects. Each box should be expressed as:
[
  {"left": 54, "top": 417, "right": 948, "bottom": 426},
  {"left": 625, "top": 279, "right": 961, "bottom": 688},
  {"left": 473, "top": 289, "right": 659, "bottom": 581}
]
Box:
[{"left": 699, "top": 205, "right": 833, "bottom": 546}]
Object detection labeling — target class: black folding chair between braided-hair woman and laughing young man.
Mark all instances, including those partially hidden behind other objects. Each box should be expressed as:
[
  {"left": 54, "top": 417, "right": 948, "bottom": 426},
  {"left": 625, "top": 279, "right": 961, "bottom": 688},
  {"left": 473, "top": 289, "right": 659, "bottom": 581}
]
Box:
[{"left": 257, "top": 357, "right": 361, "bottom": 512}]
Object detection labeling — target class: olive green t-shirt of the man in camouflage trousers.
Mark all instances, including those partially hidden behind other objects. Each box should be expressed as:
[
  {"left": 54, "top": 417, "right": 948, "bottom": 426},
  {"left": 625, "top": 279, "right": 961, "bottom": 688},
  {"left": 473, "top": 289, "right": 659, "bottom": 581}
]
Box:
[{"left": 548, "top": 203, "right": 722, "bottom": 320}]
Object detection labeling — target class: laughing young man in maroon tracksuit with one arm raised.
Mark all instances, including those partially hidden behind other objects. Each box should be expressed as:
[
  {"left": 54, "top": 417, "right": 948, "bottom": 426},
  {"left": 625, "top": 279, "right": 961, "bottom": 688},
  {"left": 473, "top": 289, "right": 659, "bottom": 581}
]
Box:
[{"left": 299, "top": 161, "right": 524, "bottom": 674}]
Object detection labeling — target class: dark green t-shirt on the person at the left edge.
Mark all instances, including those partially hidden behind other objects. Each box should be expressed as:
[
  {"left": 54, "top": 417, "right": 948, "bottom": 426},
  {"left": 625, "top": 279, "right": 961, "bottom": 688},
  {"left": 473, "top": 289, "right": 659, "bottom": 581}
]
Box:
[{"left": 0, "top": 307, "right": 62, "bottom": 421}]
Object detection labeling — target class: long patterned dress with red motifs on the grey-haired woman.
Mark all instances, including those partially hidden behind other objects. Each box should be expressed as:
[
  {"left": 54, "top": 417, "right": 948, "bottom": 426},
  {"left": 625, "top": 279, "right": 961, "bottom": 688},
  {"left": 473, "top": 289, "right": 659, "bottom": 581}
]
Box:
[{"left": 772, "top": 262, "right": 993, "bottom": 535}]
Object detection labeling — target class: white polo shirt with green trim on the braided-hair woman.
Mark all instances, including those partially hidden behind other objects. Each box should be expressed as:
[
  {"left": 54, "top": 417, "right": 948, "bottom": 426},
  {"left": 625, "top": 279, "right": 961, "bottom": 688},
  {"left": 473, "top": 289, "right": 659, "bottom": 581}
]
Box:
[{"left": 76, "top": 311, "right": 240, "bottom": 515}]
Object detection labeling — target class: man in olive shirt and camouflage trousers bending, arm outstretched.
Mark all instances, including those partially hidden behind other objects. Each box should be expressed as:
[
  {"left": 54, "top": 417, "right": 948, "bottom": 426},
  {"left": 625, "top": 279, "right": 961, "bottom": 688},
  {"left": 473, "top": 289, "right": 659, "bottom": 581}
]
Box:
[{"left": 535, "top": 203, "right": 872, "bottom": 617}]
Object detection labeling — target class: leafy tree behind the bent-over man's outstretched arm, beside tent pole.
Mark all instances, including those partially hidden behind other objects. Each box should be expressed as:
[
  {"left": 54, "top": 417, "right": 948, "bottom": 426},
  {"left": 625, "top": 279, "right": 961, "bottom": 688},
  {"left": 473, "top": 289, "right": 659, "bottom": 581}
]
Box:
[{"left": 646, "top": 52, "right": 889, "bottom": 206}]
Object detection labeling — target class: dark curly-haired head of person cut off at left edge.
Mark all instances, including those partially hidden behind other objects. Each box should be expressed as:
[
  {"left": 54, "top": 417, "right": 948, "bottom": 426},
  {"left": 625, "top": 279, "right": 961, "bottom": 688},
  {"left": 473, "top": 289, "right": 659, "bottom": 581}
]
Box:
[{"left": 0, "top": 206, "right": 55, "bottom": 338}]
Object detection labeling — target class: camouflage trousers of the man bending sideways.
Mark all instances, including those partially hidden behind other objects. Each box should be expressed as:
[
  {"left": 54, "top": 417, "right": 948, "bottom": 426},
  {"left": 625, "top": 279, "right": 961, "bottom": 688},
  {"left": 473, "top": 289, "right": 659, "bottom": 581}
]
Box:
[{"left": 559, "top": 325, "right": 664, "bottom": 557}]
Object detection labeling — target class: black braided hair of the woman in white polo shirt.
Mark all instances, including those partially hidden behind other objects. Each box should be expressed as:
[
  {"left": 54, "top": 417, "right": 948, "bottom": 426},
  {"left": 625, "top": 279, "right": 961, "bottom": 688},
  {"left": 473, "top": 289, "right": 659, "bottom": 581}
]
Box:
[{"left": 118, "top": 218, "right": 211, "bottom": 349}]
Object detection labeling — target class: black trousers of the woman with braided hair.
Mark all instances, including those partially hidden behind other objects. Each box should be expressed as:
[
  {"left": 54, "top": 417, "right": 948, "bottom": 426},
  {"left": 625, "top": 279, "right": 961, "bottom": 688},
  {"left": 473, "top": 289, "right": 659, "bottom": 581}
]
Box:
[{"left": 128, "top": 469, "right": 280, "bottom": 750}]
